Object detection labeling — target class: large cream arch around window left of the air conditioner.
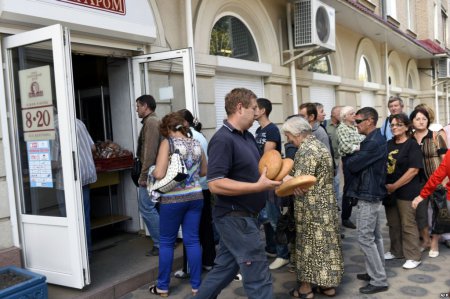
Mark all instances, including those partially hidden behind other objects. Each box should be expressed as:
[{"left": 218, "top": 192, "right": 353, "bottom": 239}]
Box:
[{"left": 194, "top": 0, "right": 280, "bottom": 65}]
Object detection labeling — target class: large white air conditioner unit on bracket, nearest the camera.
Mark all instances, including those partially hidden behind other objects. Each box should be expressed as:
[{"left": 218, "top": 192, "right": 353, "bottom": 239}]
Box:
[{"left": 293, "top": 0, "right": 336, "bottom": 51}]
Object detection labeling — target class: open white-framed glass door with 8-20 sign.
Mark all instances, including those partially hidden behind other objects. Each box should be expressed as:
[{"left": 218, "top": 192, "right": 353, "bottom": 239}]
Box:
[{"left": 1, "top": 25, "right": 90, "bottom": 288}]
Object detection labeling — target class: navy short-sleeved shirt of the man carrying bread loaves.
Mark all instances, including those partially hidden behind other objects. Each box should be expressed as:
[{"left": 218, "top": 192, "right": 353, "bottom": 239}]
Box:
[{"left": 207, "top": 121, "right": 267, "bottom": 218}]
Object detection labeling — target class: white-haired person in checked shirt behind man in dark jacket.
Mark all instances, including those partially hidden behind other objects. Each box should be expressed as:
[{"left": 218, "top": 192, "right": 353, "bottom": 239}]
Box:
[{"left": 336, "top": 106, "right": 364, "bottom": 229}]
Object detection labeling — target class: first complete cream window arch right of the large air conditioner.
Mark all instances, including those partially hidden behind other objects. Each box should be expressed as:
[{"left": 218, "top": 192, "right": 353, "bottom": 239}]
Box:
[{"left": 354, "top": 38, "right": 381, "bottom": 83}]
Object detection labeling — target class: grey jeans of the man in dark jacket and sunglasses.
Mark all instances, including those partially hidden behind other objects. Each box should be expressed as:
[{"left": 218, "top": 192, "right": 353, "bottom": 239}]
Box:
[{"left": 356, "top": 200, "right": 388, "bottom": 286}]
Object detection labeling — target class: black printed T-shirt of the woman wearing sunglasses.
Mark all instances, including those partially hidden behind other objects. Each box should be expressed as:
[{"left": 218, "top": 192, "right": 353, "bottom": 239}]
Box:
[{"left": 386, "top": 138, "right": 423, "bottom": 201}]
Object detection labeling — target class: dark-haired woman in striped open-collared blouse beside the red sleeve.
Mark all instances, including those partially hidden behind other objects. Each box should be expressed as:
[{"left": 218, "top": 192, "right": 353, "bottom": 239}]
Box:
[{"left": 409, "top": 108, "right": 448, "bottom": 257}]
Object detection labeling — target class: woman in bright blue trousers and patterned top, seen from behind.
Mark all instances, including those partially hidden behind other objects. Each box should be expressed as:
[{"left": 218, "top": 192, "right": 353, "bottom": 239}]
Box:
[{"left": 149, "top": 113, "right": 207, "bottom": 297}]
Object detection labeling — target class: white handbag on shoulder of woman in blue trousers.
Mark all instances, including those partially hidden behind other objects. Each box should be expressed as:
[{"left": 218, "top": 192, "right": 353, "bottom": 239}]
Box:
[{"left": 147, "top": 137, "right": 188, "bottom": 196}]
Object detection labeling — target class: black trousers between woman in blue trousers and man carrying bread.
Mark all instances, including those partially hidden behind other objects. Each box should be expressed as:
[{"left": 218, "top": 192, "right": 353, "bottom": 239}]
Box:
[{"left": 183, "top": 189, "right": 216, "bottom": 273}]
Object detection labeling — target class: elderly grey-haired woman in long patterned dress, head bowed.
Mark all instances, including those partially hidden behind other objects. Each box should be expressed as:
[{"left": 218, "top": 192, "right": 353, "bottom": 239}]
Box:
[{"left": 282, "top": 117, "right": 344, "bottom": 298}]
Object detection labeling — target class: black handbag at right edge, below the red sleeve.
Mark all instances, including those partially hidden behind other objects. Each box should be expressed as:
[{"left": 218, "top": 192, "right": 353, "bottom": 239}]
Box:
[{"left": 428, "top": 185, "right": 450, "bottom": 235}]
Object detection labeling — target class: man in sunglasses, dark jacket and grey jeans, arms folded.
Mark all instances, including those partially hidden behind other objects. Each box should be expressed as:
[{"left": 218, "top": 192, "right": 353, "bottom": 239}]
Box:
[{"left": 347, "top": 107, "right": 388, "bottom": 294}]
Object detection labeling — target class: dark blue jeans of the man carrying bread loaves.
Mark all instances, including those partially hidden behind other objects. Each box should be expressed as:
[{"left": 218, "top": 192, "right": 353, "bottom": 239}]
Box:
[{"left": 197, "top": 216, "right": 273, "bottom": 299}]
